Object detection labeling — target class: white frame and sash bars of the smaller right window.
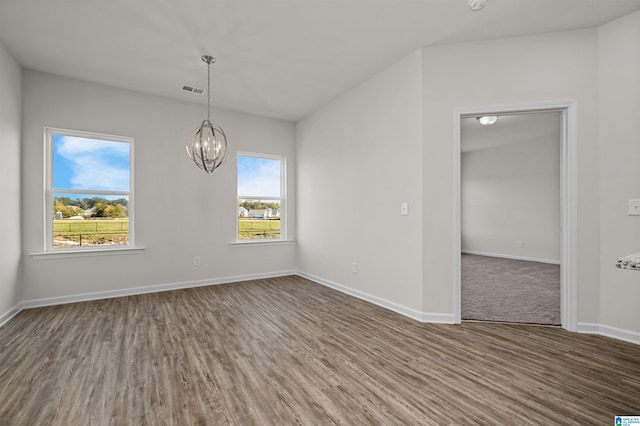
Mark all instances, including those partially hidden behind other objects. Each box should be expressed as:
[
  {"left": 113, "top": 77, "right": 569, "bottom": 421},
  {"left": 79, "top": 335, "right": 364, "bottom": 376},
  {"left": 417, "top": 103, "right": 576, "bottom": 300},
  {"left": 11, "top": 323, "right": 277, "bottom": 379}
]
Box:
[{"left": 235, "top": 151, "right": 288, "bottom": 244}]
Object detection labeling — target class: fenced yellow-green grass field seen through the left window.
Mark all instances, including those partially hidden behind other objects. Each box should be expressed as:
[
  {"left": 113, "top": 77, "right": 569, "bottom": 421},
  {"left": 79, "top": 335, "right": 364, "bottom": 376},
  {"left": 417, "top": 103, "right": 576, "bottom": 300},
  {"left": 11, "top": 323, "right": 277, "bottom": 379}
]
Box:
[{"left": 53, "top": 218, "right": 129, "bottom": 247}]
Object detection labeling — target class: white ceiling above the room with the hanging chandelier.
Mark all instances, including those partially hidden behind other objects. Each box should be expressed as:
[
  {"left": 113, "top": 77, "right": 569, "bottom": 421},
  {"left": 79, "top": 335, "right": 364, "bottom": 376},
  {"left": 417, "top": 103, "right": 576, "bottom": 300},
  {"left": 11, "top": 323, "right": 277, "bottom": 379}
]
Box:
[{"left": 0, "top": 0, "right": 640, "bottom": 120}]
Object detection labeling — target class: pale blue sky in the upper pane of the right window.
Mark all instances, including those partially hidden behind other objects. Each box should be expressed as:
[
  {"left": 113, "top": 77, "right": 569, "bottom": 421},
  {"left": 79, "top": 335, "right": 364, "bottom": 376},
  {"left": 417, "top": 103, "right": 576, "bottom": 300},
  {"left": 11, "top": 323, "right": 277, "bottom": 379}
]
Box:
[{"left": 238, "top": 155, "right": 282, "bottom": 198}]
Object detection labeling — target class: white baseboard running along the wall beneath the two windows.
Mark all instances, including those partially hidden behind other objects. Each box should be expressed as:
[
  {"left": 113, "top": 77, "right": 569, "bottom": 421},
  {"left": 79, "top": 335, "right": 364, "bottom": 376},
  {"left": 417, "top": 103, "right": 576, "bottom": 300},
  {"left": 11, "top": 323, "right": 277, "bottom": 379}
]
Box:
[{"left": 22, "top": 271, "right": 296, "bottom": 309}]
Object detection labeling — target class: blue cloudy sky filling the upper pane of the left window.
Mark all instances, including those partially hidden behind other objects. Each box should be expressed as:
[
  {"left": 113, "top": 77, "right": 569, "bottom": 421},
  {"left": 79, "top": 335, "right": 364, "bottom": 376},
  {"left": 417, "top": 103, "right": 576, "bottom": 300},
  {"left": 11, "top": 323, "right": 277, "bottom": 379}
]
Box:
[{"left": 53, "top": 134, "right": 131, "bottom": 192}]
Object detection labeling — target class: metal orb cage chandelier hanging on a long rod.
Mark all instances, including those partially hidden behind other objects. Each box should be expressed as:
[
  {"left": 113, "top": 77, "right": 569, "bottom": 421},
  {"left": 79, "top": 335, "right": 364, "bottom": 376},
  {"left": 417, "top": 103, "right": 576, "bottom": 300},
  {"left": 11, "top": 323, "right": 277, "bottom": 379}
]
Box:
[{"left": 186, "top": 55, "right": 229, "bottom": 174}]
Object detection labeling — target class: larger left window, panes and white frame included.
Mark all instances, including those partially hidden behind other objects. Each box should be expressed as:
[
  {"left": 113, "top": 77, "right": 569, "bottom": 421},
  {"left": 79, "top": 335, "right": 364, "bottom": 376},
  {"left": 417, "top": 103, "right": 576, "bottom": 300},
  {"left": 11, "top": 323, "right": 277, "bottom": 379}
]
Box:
[{"left": 45, "top": 128, "right": 133, "bottom": 251}]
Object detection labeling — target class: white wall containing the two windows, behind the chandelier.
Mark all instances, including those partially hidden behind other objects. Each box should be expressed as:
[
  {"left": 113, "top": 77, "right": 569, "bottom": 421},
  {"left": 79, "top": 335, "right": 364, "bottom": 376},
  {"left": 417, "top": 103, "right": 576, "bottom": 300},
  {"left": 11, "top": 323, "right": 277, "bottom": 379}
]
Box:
[{"left": 23, "top": 71, "right": 295, "bottom": 300}]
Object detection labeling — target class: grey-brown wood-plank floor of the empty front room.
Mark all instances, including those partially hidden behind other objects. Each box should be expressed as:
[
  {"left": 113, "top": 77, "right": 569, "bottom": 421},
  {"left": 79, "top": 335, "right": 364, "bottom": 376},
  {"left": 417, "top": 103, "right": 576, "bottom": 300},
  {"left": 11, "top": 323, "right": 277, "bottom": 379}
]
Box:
[{"left": 0, "top": 277, "right": 640, "bottom": 425}]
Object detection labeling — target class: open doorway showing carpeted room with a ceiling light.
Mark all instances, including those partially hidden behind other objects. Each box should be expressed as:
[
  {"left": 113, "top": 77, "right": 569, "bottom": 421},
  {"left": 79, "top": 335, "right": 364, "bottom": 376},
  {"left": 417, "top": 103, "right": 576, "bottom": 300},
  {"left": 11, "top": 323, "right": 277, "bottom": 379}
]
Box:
[{"left": 460, "top": 111, "right": 561, "bottom": 325}]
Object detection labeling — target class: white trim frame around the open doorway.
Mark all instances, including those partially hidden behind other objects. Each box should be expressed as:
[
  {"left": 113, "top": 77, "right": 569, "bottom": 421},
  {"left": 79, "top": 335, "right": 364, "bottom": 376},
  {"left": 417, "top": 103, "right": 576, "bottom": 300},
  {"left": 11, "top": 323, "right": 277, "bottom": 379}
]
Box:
[{"left": 453, "top": 101, "right": 578, "bottom": 331}]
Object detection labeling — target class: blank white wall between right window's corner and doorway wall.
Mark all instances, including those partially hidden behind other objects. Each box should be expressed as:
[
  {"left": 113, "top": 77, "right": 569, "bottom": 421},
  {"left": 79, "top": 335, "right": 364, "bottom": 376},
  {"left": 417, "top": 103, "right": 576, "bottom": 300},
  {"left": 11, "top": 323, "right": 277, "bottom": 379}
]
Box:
[{"left": 296, "top": 51, "right": 422, "bottom": 311}]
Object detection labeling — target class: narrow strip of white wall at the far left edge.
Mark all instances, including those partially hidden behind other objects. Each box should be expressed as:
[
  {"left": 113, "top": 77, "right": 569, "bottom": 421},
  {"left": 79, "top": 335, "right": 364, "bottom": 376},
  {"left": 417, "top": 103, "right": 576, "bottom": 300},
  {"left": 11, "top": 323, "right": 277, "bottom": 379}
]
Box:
[{"left": 0, "top": 44, "right": 22, "bottom": 324}]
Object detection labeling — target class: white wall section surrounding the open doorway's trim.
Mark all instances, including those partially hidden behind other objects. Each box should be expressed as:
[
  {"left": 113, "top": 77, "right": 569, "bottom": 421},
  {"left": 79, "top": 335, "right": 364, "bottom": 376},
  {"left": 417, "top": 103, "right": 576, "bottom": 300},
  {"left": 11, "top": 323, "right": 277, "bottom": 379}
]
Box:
[{"left": 422, "top": 29, "right": 600, "bottom": 322}]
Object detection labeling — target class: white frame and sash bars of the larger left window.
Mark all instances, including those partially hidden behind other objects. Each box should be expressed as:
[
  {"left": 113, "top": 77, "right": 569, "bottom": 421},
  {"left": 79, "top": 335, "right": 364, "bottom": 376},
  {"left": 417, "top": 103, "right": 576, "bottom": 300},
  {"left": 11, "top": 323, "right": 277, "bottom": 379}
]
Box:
[{"left": 44, "top": 127, "right": 135, "bottom": 254}]
